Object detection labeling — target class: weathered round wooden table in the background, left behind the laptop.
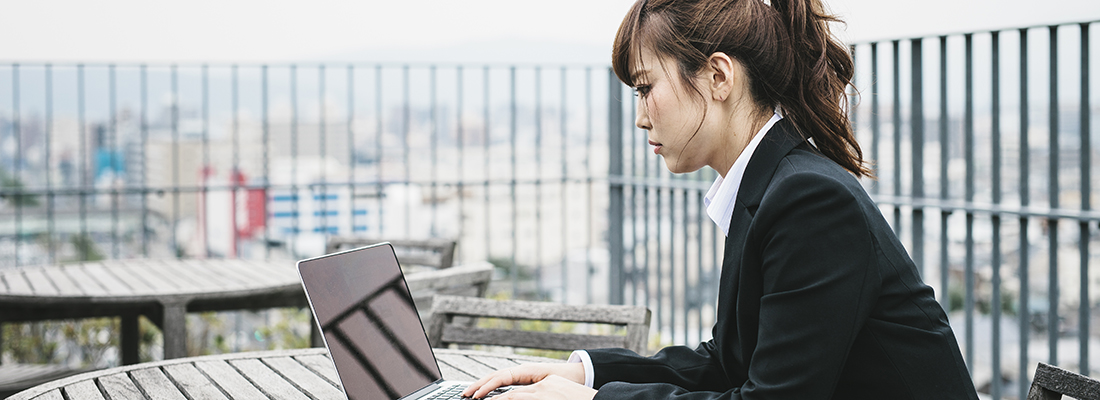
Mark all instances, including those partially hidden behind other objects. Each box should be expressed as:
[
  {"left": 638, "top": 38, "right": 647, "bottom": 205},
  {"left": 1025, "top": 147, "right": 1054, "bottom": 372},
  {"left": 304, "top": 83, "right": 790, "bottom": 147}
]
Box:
[{"left": 0, "top": 259, "right": 307, "bottom": 365}]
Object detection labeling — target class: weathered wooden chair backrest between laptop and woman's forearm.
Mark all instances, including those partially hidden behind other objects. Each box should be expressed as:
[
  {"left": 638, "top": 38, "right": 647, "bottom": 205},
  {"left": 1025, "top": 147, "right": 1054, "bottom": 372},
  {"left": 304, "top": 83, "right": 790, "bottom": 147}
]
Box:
[{"left": 428, "top": 296, "right": 650, "bottom": 354}]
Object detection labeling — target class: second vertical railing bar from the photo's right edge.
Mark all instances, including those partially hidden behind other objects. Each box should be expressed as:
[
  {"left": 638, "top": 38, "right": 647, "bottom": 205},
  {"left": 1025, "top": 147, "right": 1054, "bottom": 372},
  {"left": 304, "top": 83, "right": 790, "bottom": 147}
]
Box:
[{"left": 1046, "top": 25, "right": 1060, "bottom": 365}]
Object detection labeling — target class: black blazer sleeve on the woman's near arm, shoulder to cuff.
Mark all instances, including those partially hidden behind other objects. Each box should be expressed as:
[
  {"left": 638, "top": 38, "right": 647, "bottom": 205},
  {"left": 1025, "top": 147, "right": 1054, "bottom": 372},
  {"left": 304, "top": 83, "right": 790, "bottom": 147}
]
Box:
[{"left": 590, "top": 173, "right": 878, "bottom": 400}]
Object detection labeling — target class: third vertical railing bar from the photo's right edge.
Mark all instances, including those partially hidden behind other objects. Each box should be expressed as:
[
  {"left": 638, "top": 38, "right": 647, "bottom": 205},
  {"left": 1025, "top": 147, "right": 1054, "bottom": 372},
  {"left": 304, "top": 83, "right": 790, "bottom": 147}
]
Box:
[{"left": 1016, "top": 27, "right": 1031, "bottom": 399}]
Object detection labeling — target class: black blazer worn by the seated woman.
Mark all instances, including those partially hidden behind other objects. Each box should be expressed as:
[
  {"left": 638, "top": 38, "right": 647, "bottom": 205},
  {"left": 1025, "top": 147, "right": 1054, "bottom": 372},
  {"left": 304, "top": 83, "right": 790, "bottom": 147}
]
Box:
[{"left": 589, "top": 120, "right": 978, "bottom": 400}]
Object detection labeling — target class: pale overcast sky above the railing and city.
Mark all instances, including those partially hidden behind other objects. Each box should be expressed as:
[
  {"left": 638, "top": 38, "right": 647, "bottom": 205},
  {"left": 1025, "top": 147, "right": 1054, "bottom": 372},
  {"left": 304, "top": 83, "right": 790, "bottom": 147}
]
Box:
[{"left": 0, "top": 0, "right": 1100, "bottom": 63}]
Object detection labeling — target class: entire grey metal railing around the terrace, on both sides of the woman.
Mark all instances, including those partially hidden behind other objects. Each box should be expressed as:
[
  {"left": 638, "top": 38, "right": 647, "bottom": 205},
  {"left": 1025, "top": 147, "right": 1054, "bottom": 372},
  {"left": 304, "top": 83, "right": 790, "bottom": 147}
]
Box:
[{"left": 0, "top": 17, "right": 1100, "bottom": 398}]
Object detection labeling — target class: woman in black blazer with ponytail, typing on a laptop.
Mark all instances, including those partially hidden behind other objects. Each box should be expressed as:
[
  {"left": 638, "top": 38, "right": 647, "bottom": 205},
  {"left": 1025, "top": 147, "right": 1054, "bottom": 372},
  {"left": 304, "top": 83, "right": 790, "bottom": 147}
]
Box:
[{"left": 464, "top": 0, "right": 977, "bottom": 399}]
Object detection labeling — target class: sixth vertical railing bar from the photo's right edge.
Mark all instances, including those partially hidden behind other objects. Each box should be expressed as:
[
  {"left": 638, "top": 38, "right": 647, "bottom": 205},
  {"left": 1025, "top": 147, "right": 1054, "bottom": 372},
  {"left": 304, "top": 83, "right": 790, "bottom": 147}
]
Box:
[{"left": 939, "top": 36, "right": 952, "bottom": 311}]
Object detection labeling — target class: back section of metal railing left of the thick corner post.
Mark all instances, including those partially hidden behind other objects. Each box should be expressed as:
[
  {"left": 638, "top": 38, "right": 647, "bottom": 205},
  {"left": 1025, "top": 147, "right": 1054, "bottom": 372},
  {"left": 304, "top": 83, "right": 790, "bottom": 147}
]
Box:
[{"left": 0, "top": 64, "right": 607, "bottom": 302}]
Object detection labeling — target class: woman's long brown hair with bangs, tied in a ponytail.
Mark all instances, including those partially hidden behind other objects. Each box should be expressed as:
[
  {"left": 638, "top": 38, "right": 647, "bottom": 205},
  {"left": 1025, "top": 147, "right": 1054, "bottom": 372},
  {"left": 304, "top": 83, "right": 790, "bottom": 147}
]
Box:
[{"left": 612, "top": 0, "right": 872, "bottom": 177}]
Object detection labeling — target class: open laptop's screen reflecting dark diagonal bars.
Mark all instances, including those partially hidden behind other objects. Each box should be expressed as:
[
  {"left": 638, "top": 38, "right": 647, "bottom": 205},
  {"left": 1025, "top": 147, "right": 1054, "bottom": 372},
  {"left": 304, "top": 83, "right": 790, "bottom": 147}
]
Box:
[{"left": 298, "top": 243, "right": 442, "bottom": 400}]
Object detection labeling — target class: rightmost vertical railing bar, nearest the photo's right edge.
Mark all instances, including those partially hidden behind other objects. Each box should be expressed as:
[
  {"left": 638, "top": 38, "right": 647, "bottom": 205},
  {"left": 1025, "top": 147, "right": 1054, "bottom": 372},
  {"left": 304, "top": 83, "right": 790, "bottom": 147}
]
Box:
[{"left": 1077, "top": 22, "right": 1092, "bottom": 376}]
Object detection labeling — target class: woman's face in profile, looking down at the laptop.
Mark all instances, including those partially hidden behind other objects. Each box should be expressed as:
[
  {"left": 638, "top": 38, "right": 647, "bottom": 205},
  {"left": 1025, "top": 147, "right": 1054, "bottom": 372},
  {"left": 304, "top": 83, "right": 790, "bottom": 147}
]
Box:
[{"left": 633, "top": 46, "right": 718, "bottom": 174}]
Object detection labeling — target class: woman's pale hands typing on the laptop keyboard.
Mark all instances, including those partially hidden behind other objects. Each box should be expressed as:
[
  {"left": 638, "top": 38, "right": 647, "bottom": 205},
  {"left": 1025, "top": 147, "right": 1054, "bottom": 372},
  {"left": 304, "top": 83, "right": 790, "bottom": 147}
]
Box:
[{"left": 462, "top": 363, "right": 596, "bottom": 399}]
